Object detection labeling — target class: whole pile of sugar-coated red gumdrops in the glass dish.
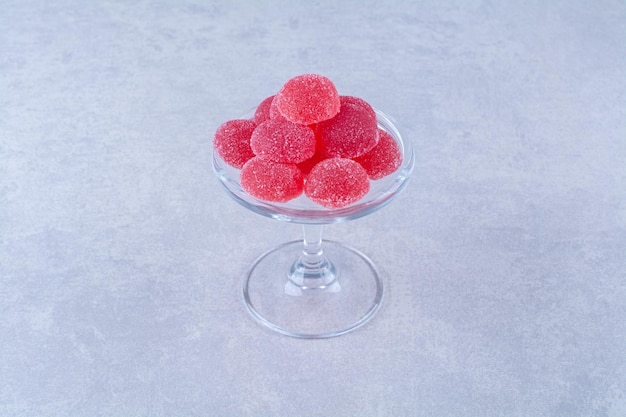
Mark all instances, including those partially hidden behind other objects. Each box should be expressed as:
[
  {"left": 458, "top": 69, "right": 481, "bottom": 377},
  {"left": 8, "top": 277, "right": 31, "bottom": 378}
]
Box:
[{"left": 213, "top": 74, "right": 402, "bottom": 208}]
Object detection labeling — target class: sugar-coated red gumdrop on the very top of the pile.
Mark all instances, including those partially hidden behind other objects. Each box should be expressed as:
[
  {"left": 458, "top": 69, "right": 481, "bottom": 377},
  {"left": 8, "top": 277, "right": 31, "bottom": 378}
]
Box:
[{"left": 274, "top": 74, "right": 341, "bottom": 125}]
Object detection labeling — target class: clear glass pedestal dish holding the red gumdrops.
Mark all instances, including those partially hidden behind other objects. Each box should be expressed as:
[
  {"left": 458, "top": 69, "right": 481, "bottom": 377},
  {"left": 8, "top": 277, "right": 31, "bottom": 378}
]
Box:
[{"left": 213, "top": 109, "right": 414, "bottom": 339}]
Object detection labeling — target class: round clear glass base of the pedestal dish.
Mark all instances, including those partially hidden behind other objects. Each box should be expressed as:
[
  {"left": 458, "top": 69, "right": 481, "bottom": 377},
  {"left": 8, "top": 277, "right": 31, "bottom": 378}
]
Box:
[{"left": 243, "top": 240, "right": 383, "bottom": 339}]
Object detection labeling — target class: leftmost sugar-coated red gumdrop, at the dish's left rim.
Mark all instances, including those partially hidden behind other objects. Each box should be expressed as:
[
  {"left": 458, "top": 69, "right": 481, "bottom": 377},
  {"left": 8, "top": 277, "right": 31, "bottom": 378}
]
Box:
[{"left": 213, "top": 119, "right": 256, "bottom": 169}]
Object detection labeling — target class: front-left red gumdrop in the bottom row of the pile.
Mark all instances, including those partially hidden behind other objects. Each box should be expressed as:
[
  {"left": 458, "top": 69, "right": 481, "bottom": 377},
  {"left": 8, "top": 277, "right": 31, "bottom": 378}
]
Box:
[{"left": 240, "top": 157, "right": 304, "bottom": 203}]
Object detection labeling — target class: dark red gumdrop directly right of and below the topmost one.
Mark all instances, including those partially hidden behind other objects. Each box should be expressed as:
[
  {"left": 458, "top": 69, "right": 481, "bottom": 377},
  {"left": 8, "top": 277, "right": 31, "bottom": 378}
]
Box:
[{"left": 315, "top": 103, "right": 378, "bottom": 158}]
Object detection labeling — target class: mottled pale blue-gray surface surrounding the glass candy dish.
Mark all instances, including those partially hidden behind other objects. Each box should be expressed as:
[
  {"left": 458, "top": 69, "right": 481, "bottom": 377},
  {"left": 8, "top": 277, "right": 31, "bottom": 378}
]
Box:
[{"left": 0, "top": 0, "right": 626, "bottom": 417}]
